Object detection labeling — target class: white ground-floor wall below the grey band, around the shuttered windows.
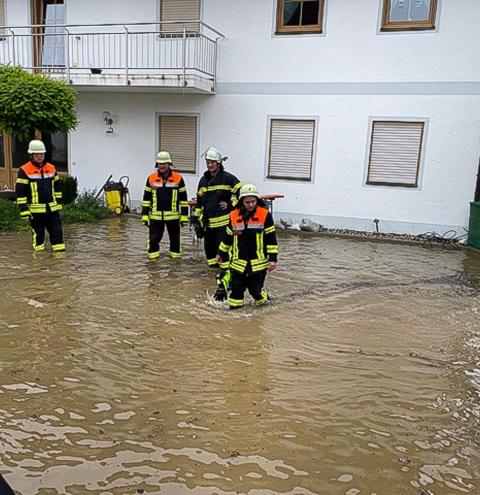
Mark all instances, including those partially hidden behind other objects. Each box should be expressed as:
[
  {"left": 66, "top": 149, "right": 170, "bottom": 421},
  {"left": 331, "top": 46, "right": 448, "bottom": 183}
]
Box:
[{"left": 71, "top": 94, "right": 480, "bottom": 236}]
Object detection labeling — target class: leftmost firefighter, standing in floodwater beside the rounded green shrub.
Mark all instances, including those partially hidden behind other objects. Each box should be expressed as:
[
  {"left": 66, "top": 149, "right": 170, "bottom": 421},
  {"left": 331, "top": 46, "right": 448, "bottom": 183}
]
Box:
[{"left": 16, "top": 139, "right": 65, "bottom": 252}]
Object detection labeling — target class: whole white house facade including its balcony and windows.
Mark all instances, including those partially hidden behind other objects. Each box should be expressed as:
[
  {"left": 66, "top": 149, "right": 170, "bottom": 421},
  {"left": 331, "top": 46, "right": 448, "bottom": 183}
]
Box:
[{"left": 0, "top": 0, "right": 480, "bottom": 234}]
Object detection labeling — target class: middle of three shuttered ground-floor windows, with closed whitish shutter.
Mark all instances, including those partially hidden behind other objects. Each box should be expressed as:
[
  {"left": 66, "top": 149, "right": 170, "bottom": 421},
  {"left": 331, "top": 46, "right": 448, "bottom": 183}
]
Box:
[{"left": 267, "top": 119, "right": 315, "bottom": 181}]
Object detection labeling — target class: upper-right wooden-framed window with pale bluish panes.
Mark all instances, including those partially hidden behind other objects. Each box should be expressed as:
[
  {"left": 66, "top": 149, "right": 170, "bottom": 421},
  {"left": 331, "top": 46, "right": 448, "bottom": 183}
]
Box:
[{"left": 382, "top": 0, "right": 437, "bottom": 31}]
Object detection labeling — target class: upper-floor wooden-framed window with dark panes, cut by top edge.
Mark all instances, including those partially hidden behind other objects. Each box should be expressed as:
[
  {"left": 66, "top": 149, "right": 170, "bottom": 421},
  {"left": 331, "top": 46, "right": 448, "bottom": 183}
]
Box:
[{"left": 276, "top": 0, "right": 324, "bottom": 34}]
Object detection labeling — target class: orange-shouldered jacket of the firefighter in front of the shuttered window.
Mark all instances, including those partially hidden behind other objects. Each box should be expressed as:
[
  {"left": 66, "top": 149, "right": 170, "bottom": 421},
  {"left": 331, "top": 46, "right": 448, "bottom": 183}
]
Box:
[{"left": 142, "top": 169, "right": 188, "bottom": 222}]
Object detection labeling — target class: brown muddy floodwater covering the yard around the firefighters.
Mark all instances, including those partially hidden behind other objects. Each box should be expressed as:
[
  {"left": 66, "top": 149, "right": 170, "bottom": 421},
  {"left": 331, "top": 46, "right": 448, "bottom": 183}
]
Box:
[{"left": 0, "top": 219, "right": 480, "bottom": 495}]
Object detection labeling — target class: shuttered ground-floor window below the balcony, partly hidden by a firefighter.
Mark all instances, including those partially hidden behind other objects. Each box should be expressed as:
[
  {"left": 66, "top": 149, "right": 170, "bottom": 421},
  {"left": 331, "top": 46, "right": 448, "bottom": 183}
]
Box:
[{"left": 158, "top": 115, "right": 198, "bottom": 174}]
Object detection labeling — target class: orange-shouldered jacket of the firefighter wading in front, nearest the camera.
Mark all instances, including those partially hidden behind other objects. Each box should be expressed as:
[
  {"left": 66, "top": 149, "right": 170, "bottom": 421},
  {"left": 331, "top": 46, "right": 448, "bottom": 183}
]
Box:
[{"left": 218, "top": 206, "right": 278, "bottom": 273}]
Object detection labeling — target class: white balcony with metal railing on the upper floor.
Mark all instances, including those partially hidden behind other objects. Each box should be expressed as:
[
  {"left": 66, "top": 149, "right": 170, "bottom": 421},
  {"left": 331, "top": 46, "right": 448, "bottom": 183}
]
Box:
[{"left": 0, "top": 20, "right": 224, "bottom": 94}]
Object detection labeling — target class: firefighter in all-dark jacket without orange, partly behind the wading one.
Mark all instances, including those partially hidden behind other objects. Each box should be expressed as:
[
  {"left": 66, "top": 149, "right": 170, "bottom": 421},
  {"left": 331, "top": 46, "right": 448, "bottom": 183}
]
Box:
[{"left": 193, "top": 147, "right": 241, "bottom": 270}]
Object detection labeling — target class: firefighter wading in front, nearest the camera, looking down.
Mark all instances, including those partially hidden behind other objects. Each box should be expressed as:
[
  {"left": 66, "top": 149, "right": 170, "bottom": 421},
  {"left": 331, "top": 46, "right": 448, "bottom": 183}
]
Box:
[{"left": 217, "top": 184, "right": 278, "bottom": 309}]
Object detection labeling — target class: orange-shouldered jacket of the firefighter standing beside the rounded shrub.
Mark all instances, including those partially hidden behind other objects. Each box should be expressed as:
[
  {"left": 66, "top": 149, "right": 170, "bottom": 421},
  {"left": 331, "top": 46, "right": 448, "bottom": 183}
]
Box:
[{"left": 15, "top": 162, "right": 62, "bottom": 217}]
